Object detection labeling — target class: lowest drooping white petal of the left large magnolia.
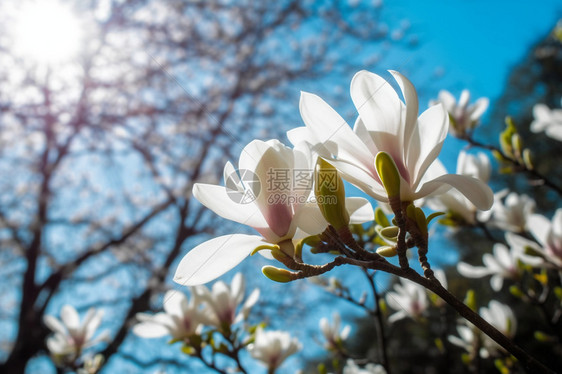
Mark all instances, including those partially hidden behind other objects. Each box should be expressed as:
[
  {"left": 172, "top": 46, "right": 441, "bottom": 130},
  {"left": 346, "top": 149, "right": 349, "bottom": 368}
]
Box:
[{"left": 174, "top": 234, "right": 268, "bottom": 286}]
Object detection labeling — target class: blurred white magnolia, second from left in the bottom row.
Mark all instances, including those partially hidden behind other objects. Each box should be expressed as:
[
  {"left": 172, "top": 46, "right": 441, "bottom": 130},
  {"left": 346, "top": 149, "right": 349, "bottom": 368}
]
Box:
[{"left": 133, "top": 290, "right": 208, "bottom": 340}]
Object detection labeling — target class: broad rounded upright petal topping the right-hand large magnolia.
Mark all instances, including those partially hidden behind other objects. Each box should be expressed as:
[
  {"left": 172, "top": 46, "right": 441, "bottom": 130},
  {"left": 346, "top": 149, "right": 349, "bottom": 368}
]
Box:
[{"left": 351, "top": 70, "right": 403, "bottom": 137}]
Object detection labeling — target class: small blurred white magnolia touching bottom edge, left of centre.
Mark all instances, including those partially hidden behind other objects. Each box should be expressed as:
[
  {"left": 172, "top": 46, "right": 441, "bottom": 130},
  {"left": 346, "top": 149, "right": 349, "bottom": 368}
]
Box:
[{"left": 248, "top": 328, "right": 302, "bottom": 371}]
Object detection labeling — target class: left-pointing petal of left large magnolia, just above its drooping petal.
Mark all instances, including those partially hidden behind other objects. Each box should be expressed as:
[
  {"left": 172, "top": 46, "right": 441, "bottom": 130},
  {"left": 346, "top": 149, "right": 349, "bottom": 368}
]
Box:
[{"left": 193, "top": 183, "right": 268, "bottom": 228}]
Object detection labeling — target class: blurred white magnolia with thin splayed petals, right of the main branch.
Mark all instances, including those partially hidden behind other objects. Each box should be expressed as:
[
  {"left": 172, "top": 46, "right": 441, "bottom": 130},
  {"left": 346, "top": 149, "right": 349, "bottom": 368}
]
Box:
[{"left": 457, "top": 232, "right": 543, "bottom": 291}]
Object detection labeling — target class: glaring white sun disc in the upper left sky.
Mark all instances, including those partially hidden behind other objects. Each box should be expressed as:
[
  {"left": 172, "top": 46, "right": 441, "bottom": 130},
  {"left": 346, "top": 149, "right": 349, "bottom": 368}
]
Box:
[{"left": 14, "top": 0, "right": 82, "bottom": 64}]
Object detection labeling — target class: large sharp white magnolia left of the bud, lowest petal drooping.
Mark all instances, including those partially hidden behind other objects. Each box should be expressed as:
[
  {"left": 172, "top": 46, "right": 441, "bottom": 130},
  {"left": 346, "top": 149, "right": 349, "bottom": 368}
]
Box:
[{"left": 174, "top": 140, "right": 374, "bottom": 285}]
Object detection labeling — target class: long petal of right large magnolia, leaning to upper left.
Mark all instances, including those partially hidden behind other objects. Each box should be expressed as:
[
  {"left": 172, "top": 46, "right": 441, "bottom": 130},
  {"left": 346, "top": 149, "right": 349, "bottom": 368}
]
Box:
[{"left": 300, "top": 92, "right": 371, "bottom": 168}]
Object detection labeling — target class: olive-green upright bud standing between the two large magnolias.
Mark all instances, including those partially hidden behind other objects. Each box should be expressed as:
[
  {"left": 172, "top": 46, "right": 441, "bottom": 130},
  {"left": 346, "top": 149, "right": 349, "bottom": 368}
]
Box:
[{"left": 314, "top": 158, "right": 349, "bottom": 230}]
